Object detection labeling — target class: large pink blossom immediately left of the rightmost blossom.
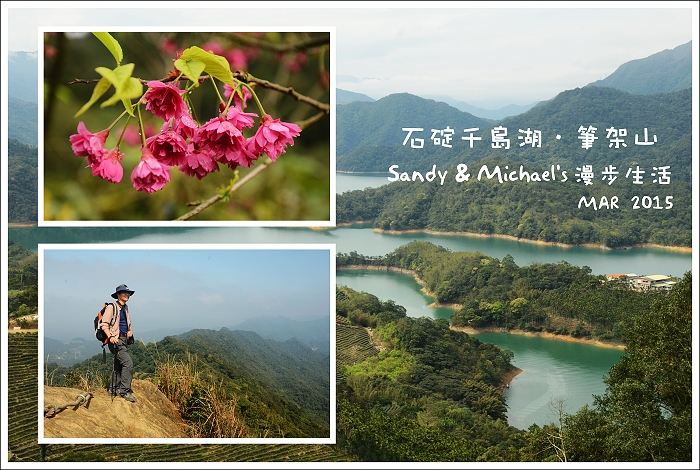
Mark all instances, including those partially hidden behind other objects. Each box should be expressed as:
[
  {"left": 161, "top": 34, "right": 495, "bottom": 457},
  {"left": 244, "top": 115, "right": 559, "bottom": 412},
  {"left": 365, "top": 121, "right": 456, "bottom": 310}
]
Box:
[{"left": 192, "top": 114, "right": 255, "bottom": 168}]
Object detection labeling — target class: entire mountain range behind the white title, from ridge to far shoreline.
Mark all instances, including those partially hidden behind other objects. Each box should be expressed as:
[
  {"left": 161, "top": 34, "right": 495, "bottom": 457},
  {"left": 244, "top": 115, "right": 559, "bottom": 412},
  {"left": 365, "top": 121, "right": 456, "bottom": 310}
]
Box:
[{"left": 336, "top": 82, "right": 692, "bottom": 247}]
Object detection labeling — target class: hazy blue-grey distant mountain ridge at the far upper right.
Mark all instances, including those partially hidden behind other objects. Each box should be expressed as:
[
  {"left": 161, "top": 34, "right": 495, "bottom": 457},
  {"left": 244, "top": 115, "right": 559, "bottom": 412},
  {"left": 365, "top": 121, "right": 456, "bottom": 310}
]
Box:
[{"left": 588, "top": 41, "right": 693, "bottom": 95}]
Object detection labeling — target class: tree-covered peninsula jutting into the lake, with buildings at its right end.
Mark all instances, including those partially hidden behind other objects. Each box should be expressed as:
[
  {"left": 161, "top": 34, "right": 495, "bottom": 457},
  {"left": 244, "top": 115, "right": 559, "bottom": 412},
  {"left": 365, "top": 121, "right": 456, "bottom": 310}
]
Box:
[{"left": 336, "top": 241, "right": 665, "bottom": 343}]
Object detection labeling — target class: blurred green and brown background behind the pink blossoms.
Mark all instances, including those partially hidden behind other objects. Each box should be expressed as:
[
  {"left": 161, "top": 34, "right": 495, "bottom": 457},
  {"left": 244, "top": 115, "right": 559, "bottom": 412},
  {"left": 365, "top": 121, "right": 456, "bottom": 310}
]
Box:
[{"left": 44, "top": 32, "right": 331, "bottom": 221}]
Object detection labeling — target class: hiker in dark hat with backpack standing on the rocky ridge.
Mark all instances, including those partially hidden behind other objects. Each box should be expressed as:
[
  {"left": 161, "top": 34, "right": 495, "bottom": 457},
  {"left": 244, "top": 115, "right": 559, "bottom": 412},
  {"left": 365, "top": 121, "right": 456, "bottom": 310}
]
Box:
[{"left": 100, "top": 284, "right": 136, "bottom": 403}]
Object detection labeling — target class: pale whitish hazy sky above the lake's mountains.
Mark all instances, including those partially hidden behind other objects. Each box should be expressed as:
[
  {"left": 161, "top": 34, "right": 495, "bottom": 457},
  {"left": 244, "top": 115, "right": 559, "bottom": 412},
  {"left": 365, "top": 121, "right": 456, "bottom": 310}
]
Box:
[{"left": 2, "top": 2, "right": 698, "bottom": 109}]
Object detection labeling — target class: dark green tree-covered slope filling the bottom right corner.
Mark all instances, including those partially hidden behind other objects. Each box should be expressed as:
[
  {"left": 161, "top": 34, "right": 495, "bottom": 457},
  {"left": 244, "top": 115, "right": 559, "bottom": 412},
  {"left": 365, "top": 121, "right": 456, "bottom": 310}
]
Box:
[{"left": 558, "top": 271, "right": 697, "bottom": 462}]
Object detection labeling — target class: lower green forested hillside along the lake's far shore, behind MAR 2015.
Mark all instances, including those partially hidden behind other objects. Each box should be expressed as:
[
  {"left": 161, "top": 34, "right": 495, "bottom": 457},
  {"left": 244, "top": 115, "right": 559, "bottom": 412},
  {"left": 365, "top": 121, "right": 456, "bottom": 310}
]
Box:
[{"left": 336, "top": 159, "right": 692, "bottom": 248}]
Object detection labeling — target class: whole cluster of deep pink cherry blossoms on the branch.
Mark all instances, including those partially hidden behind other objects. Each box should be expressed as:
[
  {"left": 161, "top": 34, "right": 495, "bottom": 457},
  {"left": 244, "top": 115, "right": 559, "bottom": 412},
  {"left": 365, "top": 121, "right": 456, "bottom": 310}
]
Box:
[{"left": 70, "top": 77, "right": 301, "bottom": 193}]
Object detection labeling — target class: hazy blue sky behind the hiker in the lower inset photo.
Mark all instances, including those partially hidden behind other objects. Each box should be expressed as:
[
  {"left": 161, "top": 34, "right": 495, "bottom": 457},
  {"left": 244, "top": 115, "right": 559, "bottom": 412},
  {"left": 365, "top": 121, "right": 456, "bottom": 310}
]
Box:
[{"left": 39, "top": 245, "right": 335, "bottom": 339}]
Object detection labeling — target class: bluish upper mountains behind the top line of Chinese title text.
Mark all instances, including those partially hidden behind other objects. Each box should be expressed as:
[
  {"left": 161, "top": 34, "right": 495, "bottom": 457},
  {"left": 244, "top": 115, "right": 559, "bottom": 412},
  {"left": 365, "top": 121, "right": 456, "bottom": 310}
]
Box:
[{"left": 337, "top": 87, "right": 692, "bottom": 178}]
